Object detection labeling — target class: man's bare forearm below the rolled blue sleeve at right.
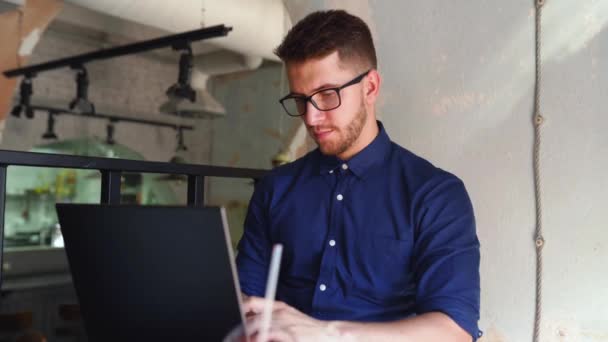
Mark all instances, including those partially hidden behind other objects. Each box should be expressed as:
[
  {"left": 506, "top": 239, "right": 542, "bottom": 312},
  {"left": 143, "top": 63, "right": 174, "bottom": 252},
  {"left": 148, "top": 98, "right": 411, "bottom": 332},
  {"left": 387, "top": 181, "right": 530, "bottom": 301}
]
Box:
[{"left": 328, "top": 312, "right": 472, "bottom": 342}]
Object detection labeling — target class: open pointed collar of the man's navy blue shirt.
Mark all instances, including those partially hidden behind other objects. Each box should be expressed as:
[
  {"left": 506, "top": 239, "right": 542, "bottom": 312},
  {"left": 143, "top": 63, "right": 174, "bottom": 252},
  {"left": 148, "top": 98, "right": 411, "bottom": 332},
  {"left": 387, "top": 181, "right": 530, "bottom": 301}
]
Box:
[{"left": 317, "top": 121, "right": 391, "bottom": 178}]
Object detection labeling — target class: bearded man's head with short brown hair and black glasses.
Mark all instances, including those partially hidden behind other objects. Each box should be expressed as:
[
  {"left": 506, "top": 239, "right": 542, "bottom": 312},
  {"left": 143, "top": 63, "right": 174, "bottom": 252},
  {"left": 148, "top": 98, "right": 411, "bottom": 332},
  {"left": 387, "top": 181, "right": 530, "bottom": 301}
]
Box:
[{"left": 275, "top": 10, "right": 380, "bottom": 159}]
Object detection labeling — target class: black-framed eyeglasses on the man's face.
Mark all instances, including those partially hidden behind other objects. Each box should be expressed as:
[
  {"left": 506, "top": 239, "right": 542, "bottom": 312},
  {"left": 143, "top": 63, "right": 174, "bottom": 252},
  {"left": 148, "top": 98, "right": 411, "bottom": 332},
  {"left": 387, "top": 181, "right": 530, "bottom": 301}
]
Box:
[{"left": 279, "top": 69, "right": 371, "bottom": 116}]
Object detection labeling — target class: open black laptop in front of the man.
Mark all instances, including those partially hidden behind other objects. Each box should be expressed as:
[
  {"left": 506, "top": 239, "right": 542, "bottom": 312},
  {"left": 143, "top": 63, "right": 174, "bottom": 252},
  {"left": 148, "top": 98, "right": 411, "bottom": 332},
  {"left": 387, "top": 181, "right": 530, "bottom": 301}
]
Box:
[{"left": 56, "top": 204, "right": 244, "bottom": 342}]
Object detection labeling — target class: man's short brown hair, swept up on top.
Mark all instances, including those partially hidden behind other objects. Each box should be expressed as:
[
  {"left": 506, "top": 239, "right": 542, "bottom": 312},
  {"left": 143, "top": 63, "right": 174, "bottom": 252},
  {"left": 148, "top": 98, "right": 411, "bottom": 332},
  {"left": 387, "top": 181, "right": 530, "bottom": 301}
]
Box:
[{"left": 274, "top": 10, "right": 377, "bottom": 68}]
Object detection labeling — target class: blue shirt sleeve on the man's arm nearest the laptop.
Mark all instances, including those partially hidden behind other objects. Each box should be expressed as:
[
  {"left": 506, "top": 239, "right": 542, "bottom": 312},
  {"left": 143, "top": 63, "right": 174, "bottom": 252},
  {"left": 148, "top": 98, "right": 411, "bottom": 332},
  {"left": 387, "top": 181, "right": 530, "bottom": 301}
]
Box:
[{"left": 236, "top": 179, "right": 272, "bottom": 297}]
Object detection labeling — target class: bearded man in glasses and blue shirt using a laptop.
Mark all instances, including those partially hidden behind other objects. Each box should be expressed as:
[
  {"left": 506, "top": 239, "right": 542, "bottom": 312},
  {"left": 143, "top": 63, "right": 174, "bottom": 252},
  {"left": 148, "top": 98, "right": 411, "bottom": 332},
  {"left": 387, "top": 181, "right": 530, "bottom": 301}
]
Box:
[{"left": 237, "top": 10, "right": 479, "bottom": 342}]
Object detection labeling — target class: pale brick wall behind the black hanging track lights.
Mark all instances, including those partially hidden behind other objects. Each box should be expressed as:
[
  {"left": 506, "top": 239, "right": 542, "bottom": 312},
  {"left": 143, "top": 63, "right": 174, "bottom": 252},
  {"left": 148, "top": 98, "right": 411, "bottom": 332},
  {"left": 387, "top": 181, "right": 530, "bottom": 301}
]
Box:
[{"left": 0, "top": 25, "right": 211, "bottom": 163}]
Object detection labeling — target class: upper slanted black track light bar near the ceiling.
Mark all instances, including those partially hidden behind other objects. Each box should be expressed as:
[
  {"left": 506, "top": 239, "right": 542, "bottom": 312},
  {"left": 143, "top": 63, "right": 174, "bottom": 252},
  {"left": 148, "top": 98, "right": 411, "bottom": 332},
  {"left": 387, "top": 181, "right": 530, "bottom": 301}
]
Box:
[{"left": 4, "top": 25, "right": 232, "bottom": 78}]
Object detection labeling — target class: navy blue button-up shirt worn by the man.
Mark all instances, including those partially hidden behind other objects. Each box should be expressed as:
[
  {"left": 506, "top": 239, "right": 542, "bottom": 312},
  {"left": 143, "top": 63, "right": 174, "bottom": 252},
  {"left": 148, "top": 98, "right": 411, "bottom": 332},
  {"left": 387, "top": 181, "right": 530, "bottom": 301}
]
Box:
[{"left": 237, "top": 122, "right": 480, "bottom": 339}]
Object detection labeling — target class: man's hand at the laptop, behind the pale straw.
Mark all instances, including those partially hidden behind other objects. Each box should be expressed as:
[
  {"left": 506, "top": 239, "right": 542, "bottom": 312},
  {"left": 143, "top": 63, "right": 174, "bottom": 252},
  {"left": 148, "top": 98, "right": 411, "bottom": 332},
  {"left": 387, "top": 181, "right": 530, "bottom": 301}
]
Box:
[{"left": 244, "top": 297, "right": 344, "bottom": 342}]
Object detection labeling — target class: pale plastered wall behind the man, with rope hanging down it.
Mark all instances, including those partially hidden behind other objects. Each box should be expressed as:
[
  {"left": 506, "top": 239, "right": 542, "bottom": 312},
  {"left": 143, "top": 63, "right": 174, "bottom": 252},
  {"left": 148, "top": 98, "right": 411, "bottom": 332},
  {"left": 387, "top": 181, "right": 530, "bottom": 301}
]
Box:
[{"left": 280, "top": 0, "right": 608, "bottom": 342}]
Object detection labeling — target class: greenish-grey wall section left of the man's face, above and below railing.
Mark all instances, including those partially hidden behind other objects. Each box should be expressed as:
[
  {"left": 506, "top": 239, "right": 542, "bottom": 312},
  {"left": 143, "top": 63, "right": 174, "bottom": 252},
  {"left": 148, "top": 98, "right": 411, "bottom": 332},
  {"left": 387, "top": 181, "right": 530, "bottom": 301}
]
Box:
[{"left": 207, "top": 62, "right": 301, "bottom": 243}]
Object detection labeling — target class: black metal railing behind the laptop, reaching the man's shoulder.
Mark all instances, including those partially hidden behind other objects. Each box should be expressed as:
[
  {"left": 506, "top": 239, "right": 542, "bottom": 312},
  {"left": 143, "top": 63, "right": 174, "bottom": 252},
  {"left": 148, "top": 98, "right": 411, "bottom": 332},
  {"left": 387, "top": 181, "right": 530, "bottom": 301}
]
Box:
[{"left": 0, "top": 150, "right": 268, "bottom": 288}]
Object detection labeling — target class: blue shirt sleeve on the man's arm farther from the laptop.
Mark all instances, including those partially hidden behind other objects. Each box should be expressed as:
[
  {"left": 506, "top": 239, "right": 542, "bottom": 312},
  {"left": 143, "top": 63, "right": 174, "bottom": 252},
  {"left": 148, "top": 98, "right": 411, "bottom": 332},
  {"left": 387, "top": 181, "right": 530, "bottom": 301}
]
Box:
[{"left": 413, "top": 173, "right": 480, "bottom": 341}]
